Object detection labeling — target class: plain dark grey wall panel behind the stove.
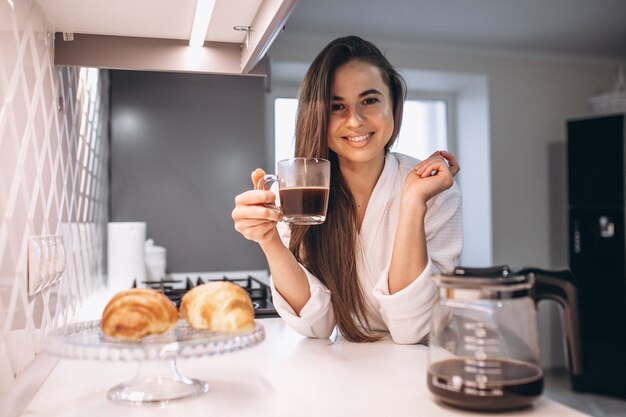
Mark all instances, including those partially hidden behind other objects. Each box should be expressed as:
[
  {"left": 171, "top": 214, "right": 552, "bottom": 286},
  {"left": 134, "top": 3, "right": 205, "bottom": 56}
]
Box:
[{"left": 110, "top": 71, "right": 268, "bottom": 272}]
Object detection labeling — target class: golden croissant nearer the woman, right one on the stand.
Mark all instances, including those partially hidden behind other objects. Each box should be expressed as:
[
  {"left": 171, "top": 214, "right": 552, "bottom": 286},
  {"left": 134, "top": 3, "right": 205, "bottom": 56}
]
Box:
[{"left": 180, "top": 281, "right": 255, "bottom": 332}]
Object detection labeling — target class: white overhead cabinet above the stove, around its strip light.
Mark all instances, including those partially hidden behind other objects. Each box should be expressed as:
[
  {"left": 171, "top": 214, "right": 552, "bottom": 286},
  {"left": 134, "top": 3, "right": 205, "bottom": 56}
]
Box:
[{"left": 37, "top": 0, "right": 297, "bottom": 76}]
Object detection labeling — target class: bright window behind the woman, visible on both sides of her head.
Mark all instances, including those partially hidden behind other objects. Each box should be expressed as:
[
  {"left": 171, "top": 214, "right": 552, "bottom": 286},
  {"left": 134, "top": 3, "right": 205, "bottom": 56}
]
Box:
[{"left": 274, "top": 98, "right": 448, "bottom": 161}]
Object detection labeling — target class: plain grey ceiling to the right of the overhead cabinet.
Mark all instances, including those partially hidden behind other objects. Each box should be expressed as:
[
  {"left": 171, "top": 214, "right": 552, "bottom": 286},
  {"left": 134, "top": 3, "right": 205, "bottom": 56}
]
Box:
[{"left": 282, "top": 0, "right": 626, "bottom": 60}]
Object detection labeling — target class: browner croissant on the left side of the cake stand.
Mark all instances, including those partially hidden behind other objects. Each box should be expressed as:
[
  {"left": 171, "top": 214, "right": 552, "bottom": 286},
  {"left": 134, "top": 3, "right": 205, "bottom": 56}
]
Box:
[{"left": 101, "top": 288, "right": 178, "bottom": 340}]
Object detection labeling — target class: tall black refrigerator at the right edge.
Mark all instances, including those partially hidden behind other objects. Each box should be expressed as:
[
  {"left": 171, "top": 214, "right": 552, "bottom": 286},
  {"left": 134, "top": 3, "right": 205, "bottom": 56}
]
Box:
[{"left": 567, "top": 114, "right": 626, "bottom": 397}]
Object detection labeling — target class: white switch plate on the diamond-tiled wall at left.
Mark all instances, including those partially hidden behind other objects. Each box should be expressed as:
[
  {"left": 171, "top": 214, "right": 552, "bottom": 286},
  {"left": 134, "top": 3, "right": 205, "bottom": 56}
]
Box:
[{"left": 28, "top": 236, "right": 65, "bottom": 296}]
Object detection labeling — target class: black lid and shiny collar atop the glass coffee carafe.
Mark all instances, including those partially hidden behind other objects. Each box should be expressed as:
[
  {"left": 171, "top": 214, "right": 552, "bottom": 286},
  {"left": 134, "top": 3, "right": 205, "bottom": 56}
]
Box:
[{"left": 432, "top": 265, "right": 534, "bottom": 299}]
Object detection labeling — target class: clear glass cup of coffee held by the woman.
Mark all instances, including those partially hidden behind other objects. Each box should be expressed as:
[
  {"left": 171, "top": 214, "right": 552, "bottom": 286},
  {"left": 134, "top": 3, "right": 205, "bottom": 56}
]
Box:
[{"left": 258, "top": 158, "right": 330, "bottom": 225}]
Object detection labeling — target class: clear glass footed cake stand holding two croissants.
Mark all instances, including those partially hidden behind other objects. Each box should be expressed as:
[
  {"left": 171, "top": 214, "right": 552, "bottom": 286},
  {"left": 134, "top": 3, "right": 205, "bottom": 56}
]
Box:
[{"left": 44, "top": 320, "right": 265, "bottom": 405}]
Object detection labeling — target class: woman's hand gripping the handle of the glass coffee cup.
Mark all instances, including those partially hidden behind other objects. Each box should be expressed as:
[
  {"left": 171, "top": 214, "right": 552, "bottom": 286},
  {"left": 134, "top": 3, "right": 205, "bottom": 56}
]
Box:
[{"left": 232, "top": 169, "right": 281, "bottom": 243}]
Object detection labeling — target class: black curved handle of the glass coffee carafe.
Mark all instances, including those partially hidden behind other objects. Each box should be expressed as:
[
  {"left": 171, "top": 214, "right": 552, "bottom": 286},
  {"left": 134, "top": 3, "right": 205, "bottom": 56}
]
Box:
[{"left": 518, "top": 268, "right": 582, "bottom": 375}]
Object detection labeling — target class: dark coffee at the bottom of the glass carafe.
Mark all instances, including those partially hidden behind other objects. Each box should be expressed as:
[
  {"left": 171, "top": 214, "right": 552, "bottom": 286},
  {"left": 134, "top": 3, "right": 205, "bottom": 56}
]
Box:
[{"left": 427, "top": 358, "right": 543, "bottom": 411}]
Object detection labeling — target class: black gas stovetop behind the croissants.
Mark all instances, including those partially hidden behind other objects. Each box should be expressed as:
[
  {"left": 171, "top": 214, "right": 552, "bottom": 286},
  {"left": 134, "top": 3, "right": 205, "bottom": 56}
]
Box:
[{"left": 133, "top": 275, "right": 278, "bottom": 318}]
